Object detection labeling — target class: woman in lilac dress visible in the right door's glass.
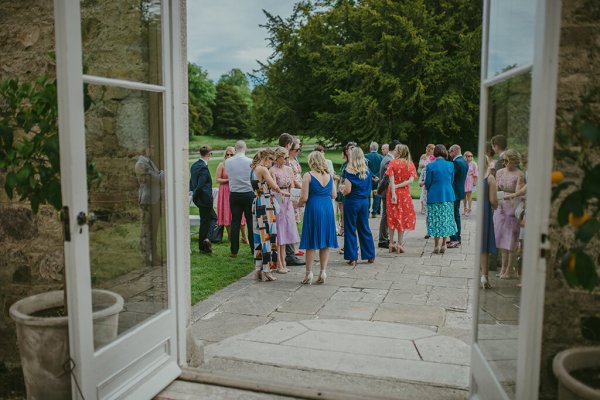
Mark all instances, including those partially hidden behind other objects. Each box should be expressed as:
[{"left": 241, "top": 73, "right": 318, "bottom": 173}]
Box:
[{"left": 494, "top": 149, "right": 525, "bottom": 279}]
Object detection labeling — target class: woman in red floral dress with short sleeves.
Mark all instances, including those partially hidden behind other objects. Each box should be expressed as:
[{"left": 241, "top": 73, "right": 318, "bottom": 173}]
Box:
[{"left": 386, "top": 144, "right": 417, "bottom": 253}]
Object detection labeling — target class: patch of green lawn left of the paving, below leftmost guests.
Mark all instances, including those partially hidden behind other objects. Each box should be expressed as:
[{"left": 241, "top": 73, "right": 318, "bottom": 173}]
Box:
[{"left": 190, "top": 228, "right": 254, "bottom": 304}]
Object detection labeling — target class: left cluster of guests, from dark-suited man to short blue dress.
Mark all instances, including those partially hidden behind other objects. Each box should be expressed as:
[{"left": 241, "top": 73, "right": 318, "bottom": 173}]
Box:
[{"left": 190, "top": 133, "right": 337, "bottom": 284}]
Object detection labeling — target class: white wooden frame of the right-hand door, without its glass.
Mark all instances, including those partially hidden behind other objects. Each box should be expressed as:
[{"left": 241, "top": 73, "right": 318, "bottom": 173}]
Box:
[{"left": 470, "top": 0, "right": 561, "bottom": 400}]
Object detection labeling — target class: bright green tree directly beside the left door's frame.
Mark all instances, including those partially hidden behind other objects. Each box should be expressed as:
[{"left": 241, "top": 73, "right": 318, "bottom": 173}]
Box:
[{"left": 188, "top": 63, "right": 217, "bottom": 135}]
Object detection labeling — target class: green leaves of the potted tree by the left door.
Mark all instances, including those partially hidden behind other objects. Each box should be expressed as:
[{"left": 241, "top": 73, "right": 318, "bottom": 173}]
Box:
[{"left": 0, "top": 76, "right": 100, "bottom": 213}]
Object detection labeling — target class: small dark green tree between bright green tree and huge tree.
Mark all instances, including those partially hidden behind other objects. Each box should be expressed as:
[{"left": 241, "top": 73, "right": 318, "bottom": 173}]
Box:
[{"left": 211, "top": 83, "right": 250, "bottom": 139}]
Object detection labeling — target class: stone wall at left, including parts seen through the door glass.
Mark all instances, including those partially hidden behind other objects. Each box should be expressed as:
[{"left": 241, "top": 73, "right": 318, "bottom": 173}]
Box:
[{"left": 0, "top": 0, "right": 162, "bottom": 398}]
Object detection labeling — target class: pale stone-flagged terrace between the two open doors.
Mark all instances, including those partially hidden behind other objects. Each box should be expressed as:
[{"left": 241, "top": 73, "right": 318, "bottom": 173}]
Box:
[{"left": 168, "top": 203, "right": 482, "bottom": 399}]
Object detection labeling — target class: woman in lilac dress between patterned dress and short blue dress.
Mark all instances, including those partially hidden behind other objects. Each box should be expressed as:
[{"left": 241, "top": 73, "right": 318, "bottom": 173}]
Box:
[{"left": 270, "top": 147, "right": 302, "bottom": 274}]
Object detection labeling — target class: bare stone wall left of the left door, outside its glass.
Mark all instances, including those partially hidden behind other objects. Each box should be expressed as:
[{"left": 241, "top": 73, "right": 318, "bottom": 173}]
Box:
[{"left": 0, "top": 0, "right": 58, "bottom": 398}]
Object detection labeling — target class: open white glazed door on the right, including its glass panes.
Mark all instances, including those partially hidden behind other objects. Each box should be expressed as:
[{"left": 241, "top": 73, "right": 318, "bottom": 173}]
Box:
[{"left": 471, "top": 0, "right": 560, "bottom": 400}]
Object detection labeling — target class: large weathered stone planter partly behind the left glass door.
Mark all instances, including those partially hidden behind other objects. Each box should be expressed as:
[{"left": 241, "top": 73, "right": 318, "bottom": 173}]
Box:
[{"left": 10, "top": 290, "right": 124, "bottom": 400}]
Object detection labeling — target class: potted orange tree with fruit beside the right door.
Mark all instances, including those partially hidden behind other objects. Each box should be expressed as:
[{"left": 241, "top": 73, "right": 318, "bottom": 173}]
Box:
[{"left": 552, "top": 88, "right": 600, "bottom": 400}]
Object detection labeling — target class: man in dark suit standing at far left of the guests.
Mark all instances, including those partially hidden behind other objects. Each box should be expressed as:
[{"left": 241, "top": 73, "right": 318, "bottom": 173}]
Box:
[{"left": 190, "top": 146, "right": 217, "bottom": 253}]
